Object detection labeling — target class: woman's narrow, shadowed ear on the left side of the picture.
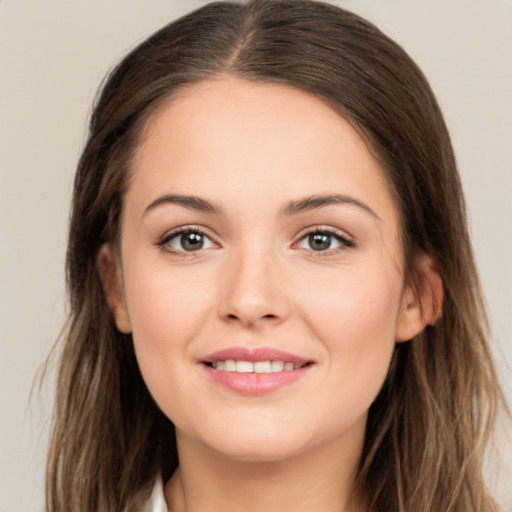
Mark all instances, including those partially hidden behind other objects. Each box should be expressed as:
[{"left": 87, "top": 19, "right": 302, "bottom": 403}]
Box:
[{"left": 96, "top": 243, "right": 132, "bottom": 334}]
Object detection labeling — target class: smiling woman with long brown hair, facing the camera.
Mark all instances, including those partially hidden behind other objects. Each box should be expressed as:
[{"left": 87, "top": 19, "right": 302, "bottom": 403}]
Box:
[{"left": 48, "top": 0, "right": 501, "bottom": 512}]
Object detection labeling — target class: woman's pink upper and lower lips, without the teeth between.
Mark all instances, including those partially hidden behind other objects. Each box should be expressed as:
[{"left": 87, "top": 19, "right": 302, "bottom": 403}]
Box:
[{"left": 201, "top": 347, "right": 314, "bottom": 396}]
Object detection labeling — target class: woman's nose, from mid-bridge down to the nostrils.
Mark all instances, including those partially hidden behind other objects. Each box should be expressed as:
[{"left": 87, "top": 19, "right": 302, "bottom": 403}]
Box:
[{"left": 219, "top": 248, "right": 290, "bottom": 328}]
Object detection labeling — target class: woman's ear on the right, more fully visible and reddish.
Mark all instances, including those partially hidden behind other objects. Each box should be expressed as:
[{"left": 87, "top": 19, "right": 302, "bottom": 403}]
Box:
[{"left": 396, "top": 254, "right": 444, "bottom": 343}]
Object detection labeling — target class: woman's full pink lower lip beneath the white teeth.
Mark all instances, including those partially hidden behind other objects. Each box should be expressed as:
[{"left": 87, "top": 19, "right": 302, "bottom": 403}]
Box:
[{"left": 202, "top": 364, "right": 313, "bottom": 396}]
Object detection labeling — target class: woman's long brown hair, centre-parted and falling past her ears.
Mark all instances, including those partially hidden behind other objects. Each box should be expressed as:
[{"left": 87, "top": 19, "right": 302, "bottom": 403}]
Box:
[{"left": 47, "top": 0, "right": 502, "bottom": 512}]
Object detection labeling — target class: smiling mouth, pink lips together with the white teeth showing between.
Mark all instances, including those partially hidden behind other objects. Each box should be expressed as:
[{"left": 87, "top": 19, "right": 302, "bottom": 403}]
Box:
[{"left": 201, "top": 347, "right": 314, "bottom": 396}]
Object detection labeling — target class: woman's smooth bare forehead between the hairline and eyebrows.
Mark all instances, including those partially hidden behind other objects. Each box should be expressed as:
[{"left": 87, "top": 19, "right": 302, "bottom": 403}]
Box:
[{"left": 129, "top": 77, "right": 396, "bottom": 228}]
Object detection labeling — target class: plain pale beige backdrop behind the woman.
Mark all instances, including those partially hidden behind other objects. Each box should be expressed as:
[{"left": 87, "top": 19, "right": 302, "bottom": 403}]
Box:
[{"left": 0, "top": 0, "right": 512, "bottom": 512}]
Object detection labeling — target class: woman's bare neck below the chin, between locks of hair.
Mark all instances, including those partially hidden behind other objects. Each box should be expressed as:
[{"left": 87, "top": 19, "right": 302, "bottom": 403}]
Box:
[{"left": 165, "top": 431, "right": 366, "bottom": 512}]
